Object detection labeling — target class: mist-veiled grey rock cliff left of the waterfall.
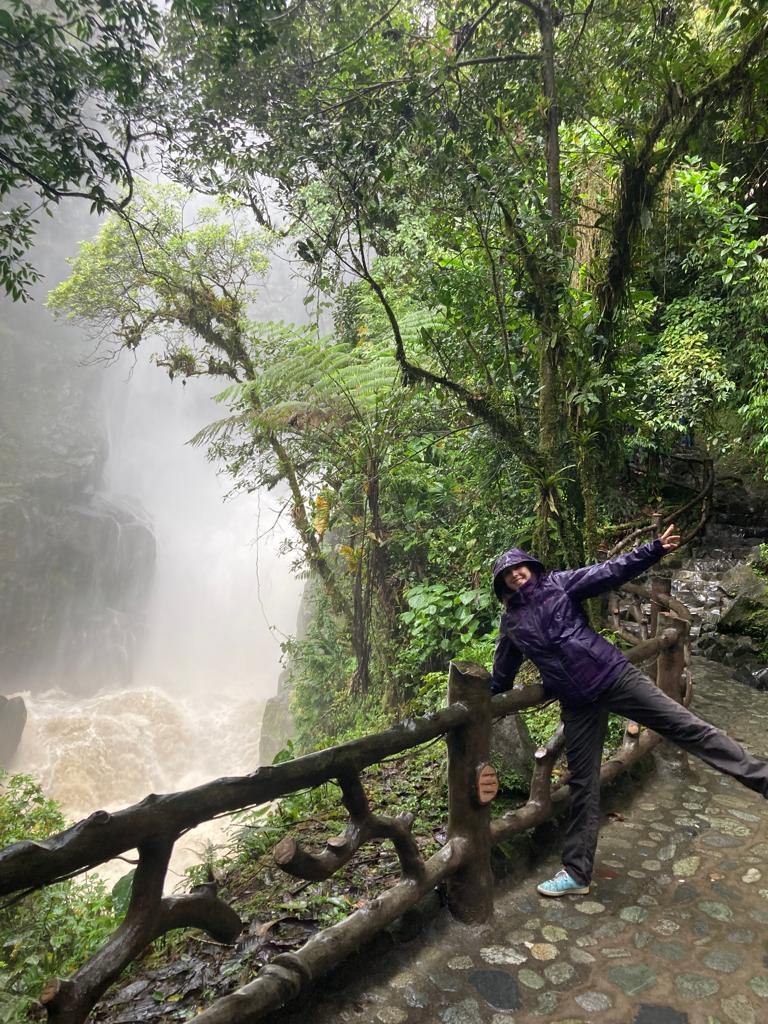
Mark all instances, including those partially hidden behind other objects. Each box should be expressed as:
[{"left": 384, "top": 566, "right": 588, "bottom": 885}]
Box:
[{"left": 0, "top": 243, "right": 155, "bottom": 692}]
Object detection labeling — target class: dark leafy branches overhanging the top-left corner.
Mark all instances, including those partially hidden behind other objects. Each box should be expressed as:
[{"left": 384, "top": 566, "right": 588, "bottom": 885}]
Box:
[{"left": 0, "top": 0, "right": 161, "bottom": 299}]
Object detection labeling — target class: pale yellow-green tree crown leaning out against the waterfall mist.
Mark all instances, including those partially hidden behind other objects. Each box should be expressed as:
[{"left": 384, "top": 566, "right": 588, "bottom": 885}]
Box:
[{"left": 48, "top": 184, "right": 271, "bottom": 380}]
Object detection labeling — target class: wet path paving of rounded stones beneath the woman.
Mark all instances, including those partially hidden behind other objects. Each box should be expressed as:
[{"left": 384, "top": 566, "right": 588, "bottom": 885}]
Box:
[{"left": 285, "top": 658, "right": 768, "bottom": 1024}]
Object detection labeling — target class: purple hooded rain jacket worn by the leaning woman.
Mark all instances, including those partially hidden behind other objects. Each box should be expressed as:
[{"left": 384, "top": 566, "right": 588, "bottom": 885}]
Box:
[{"left": 490, "top": 540, "right": 665, "bottom": 707}]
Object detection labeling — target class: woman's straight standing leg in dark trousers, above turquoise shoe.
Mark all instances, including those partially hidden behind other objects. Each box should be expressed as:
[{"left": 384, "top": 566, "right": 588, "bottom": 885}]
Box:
[{"left": 562, "top": 700, "right": 608, "bottom": 886}]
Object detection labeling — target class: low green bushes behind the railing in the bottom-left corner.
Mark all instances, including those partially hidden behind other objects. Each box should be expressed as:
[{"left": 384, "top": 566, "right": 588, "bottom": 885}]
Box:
[{"left": 0, "top": 772, "right": 118, "bottom": 1024}]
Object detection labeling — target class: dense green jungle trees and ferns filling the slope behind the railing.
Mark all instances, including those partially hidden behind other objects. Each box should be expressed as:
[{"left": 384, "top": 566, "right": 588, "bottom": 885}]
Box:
[{"left": 0, "top": 0, "right": 768, "bottom": 1015}]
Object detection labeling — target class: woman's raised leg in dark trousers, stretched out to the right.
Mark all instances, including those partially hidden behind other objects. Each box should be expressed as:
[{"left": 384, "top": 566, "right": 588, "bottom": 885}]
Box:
[{"left": 600, "top": 665, "right": 768, "bottom": 797}]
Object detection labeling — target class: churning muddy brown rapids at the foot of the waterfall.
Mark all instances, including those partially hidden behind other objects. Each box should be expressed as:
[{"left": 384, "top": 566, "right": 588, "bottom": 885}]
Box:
[{"left": 10, "top": 688, "right": 264, "bottom": 891}]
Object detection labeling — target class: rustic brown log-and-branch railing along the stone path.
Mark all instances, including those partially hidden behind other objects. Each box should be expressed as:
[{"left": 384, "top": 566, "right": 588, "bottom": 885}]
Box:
[{"left": 0, "top": 579, "right": 691, "bottom": 1024}]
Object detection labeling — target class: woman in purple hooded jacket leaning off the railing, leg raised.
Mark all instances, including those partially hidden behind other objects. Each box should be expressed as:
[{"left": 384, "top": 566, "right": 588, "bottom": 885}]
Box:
[{"left": 490, "top": 525, "right": 768, "bottom": 896}]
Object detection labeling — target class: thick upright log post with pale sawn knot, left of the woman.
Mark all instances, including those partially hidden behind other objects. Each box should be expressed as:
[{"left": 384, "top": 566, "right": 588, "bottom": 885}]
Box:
[{"left": 446, "top": 662, "right": 494, "bottom": 924}]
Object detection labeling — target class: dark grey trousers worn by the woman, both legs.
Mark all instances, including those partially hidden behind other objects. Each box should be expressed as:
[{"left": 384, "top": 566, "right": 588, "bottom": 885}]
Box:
[{"left": 562, "top": 665, "right": 768, "bottom": 885}]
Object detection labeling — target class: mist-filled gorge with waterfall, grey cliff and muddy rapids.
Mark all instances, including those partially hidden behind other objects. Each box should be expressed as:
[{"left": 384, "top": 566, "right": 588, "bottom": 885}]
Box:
[{"left": 0, "top": 193, "right": 305, "bottom": 831}]
